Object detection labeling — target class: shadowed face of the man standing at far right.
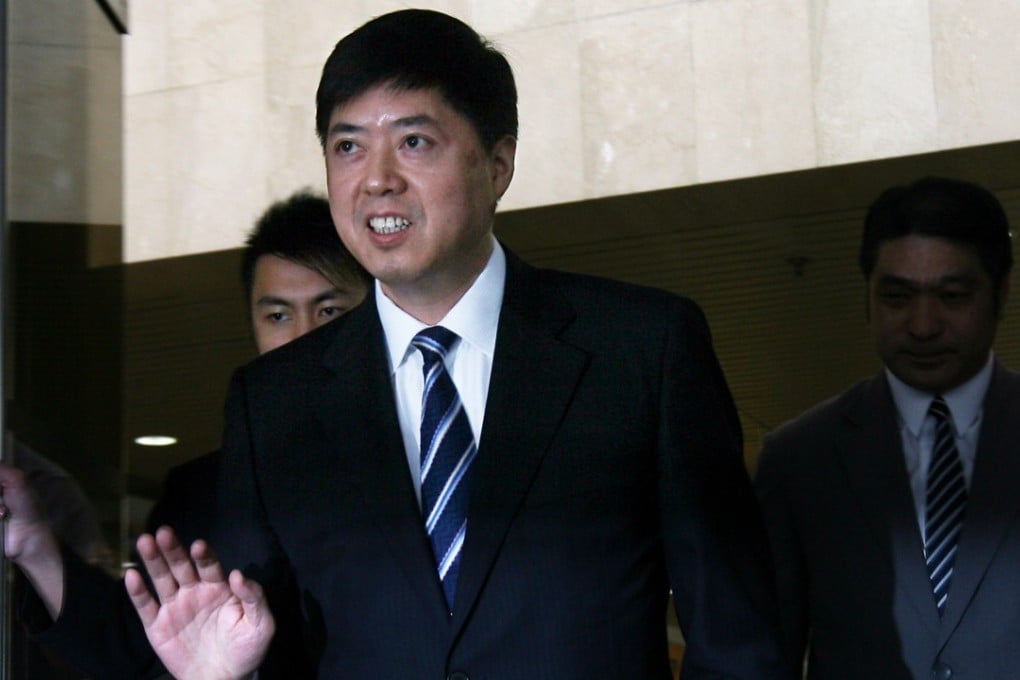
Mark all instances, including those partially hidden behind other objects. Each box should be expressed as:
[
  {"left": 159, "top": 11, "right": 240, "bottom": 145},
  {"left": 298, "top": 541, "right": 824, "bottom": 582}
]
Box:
[{"left": 868, "top": 236, "right": 1009, "bottom": 394}]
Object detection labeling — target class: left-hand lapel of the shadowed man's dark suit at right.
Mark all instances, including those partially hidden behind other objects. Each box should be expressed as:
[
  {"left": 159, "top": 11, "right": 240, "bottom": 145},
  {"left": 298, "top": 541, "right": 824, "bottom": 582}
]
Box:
[{"left": 836, "top": 374, "right": 938, "bottom": 631}]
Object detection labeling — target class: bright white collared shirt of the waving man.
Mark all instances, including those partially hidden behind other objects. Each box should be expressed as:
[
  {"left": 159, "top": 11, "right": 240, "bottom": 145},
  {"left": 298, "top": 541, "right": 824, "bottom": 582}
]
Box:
[{"left": 375, "top": 239, "right": 506, "bottom": 502}]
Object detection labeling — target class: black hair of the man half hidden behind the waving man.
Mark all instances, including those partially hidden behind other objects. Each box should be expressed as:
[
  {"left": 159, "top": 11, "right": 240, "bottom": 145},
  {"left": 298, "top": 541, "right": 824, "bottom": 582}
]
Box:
[{"left": 241, "top": 191, "right": 372, "bottom": 303}]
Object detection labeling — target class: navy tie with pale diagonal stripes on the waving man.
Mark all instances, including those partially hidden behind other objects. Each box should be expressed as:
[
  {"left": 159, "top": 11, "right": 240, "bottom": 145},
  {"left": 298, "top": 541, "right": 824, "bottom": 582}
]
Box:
[{"left": 411, "top": 326, "right": 477, "bottom": 612}]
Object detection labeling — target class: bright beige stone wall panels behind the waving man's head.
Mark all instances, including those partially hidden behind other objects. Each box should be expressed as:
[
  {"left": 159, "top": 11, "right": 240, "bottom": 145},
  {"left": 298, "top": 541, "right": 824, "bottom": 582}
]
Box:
[{"left": 124, "top": 0, "right": 1020, "bottom": 260}]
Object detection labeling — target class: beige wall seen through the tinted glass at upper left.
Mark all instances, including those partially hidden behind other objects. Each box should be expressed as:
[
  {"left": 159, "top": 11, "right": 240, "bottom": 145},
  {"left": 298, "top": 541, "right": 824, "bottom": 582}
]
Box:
[{"left": 7, "top": 0, "right": 122, "bottom": 224}]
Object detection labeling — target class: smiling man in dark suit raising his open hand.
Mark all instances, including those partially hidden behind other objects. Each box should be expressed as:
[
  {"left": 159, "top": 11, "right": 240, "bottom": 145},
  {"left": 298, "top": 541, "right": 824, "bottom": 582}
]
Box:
[{"left": 117, "top": 10, "right": 789, "bottom": 680}]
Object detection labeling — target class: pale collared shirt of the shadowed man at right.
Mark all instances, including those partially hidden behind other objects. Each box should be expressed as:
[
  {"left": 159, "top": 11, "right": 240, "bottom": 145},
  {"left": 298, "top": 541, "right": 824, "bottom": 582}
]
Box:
[{"left": 885, "top": 353, "right": 992, "bottom": 536}]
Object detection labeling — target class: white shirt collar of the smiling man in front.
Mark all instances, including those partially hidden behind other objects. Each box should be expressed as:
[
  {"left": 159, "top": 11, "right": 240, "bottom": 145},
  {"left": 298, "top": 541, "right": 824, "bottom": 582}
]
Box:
[{"left": 375, "top": 238, "right": 507, "bottom": 373}]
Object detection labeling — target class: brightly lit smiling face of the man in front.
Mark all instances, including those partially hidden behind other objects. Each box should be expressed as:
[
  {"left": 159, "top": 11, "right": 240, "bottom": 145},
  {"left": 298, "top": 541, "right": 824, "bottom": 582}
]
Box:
[{"left": 324, "top": 85, "right": 516, "bottom": 321}]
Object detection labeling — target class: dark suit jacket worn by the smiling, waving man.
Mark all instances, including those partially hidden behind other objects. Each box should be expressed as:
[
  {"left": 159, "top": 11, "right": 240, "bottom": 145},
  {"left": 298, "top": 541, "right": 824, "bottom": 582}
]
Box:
[{"left": 31, "top": 253, "right": 789, "bottom": 680}]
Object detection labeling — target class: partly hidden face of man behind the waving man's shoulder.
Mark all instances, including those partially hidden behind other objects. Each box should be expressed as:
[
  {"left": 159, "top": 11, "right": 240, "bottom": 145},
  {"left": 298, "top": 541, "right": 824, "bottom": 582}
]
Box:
[{"left": 251, "top": 255, "right": 367, "bottom": 354}]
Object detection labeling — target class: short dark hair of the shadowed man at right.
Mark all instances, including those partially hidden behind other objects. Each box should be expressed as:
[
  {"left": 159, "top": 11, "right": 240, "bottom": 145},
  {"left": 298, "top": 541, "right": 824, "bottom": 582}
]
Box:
[{"left": 858, "top": 176, "right": 1013, "bottom": 291}]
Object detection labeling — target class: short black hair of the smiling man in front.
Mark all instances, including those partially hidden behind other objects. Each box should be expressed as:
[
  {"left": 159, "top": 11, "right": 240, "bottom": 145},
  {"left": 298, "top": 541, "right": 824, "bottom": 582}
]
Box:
[{"left": 315, "top": 9, "right": 517, "bottom": 151}]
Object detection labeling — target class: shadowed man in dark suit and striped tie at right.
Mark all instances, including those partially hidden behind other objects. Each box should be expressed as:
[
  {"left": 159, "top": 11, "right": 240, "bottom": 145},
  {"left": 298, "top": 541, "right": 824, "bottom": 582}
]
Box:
[{"left": 756, "top": 178, "right": 1020, "bottom": 680}]
